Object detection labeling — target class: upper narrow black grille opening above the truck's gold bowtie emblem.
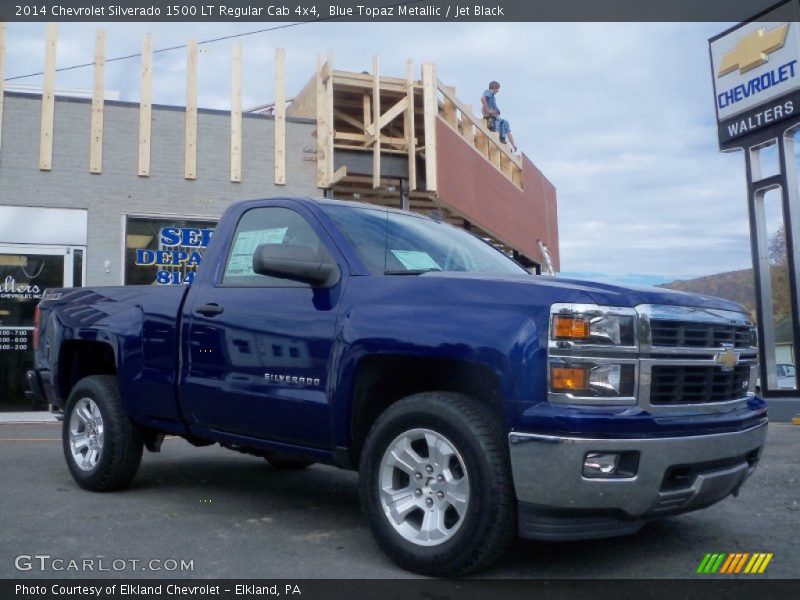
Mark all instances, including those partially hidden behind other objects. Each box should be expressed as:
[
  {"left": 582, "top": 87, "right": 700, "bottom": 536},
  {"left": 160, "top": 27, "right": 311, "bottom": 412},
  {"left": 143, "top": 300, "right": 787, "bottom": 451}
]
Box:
[{"left": 650, "top": 320, "right": 750, "bottom": 348}]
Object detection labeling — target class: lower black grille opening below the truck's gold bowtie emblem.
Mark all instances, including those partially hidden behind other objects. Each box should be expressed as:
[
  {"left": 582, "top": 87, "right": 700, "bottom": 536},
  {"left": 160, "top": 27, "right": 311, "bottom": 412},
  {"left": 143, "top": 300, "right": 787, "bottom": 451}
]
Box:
[{"left": 650, "top": 365, "right": 750, "bottom": 405}]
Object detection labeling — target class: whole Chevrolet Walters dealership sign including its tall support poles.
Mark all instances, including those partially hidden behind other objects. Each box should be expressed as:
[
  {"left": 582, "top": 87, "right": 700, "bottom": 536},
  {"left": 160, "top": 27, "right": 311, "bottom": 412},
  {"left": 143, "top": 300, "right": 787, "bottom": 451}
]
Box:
[{"left": 709, "top": 0, "right": 800, "bottom": 396}]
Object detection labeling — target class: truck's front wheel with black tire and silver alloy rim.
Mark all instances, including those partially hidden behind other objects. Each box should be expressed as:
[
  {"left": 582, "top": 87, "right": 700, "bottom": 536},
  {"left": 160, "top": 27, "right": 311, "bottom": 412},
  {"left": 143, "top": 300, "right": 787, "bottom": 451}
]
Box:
[{"left": 359, "top": 392, "right": 516, "bottom": 577}]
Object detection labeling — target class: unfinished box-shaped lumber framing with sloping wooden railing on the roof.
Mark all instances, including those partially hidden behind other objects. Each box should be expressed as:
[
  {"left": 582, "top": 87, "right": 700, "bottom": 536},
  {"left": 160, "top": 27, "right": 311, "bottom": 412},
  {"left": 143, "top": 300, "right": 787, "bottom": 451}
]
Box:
[{"left": 287, "top": 53, "right": 523, "bottom": 206}]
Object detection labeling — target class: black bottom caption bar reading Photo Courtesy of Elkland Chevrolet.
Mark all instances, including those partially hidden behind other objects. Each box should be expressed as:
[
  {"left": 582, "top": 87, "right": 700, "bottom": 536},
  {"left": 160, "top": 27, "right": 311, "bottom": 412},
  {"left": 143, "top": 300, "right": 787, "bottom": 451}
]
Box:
[{"left": 0, "top": 575, "right": 800, "bottom": 600}]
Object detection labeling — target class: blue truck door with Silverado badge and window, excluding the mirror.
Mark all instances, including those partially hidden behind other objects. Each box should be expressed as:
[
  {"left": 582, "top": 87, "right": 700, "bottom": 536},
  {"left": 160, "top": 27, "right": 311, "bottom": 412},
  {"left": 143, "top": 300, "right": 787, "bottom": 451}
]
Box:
[{"left": 180, "top": 206, "right": 345, "bottom": 447}]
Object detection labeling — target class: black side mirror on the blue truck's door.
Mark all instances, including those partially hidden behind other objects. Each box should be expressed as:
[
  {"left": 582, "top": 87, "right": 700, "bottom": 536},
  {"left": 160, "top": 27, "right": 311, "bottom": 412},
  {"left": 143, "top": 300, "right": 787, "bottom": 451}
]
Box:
[{"left": 253, "top": 244, "right": 339, "bottom": 287}]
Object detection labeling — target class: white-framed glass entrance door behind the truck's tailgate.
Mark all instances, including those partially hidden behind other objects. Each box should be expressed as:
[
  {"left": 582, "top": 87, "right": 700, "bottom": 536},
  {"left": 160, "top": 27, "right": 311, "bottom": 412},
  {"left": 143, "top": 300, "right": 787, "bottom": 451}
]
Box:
[{"left": 0, "top": 244, "right": 84, "bottom": 411}]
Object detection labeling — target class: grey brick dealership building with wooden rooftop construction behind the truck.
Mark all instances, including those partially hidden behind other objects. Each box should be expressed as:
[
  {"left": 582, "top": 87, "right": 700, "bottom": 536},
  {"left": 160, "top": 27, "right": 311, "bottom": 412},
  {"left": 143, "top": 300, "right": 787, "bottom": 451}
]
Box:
[{"left": 0, "top": 28, "right": 559, "bottom": 410}]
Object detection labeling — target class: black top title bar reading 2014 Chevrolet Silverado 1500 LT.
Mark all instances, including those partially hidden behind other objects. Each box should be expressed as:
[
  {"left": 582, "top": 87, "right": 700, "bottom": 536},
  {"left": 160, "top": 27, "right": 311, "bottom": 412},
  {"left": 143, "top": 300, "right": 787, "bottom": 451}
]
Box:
[{"left": 0, "top": 0, "right": 792, "bottom": 22}]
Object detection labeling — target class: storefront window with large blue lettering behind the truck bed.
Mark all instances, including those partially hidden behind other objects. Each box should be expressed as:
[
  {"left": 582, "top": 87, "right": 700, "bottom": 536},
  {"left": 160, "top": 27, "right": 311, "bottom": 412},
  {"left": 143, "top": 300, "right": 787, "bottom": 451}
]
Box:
[{"left": 124, "top": 217, "right": 217, "bottom": 285}]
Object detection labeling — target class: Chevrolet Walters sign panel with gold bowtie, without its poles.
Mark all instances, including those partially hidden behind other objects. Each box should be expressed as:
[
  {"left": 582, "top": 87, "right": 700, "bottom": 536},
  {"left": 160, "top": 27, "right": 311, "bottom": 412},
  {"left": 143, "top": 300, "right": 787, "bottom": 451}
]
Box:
[{"left": 710, "top": 0, "right": 800, "bottom": 148}]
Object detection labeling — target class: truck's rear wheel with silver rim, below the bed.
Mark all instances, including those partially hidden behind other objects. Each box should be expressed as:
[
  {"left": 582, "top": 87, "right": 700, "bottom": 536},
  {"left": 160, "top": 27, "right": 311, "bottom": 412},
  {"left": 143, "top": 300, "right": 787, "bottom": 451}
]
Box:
[{"left": 62, "top": 375, "right": 144, "bottom": 492}]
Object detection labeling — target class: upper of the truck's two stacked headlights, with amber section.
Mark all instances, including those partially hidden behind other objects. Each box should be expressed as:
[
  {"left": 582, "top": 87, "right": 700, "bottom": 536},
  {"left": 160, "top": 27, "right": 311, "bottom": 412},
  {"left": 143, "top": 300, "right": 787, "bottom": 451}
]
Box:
[{"left": 550, "top": 305, "right": 636, "bottom": 347}]
